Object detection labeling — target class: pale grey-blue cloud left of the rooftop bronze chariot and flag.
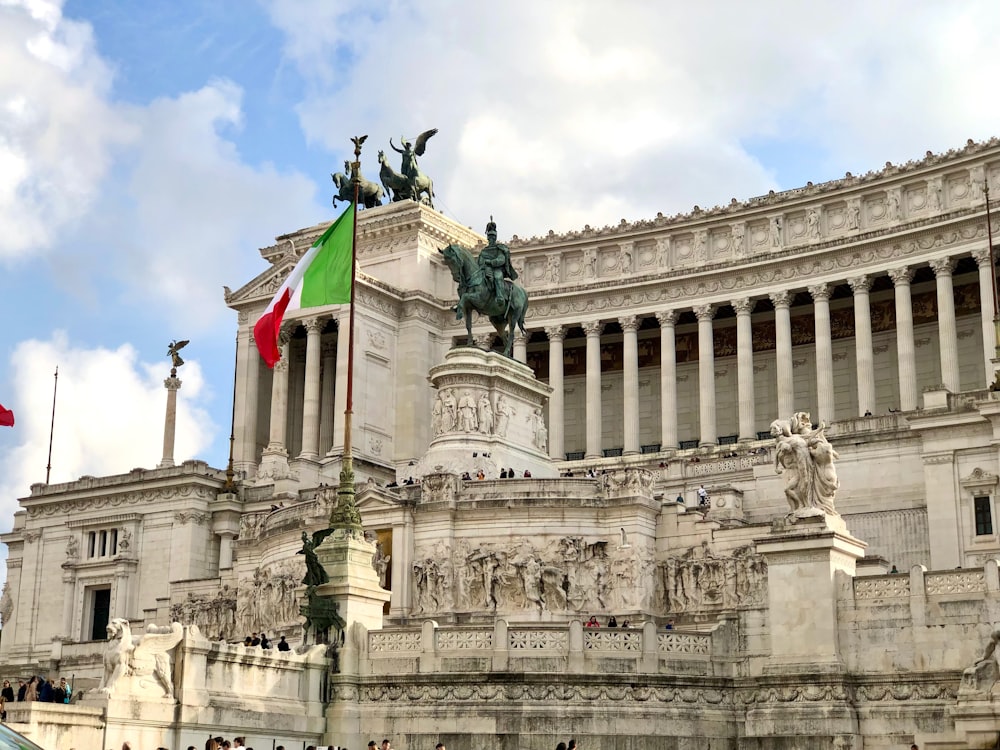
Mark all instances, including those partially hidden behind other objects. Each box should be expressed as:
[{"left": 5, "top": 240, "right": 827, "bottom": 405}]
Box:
[{"left": 107, "top": 80, "right": 322, "bottom": 331}]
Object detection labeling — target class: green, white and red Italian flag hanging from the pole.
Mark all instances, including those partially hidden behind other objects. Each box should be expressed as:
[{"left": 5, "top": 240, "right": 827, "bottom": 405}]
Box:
[{"left": 253, "top": 203, "right": 355, "bottom": 368}]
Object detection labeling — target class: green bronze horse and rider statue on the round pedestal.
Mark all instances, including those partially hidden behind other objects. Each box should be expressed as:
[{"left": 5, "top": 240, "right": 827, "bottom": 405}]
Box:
[{"left": 439, "top": 217, "right": 528, "bottom": 357}]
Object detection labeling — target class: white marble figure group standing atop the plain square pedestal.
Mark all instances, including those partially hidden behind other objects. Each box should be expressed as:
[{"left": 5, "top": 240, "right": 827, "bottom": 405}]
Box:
[{"left": 771, "top": 411, "right": 840, "bottom": 516}]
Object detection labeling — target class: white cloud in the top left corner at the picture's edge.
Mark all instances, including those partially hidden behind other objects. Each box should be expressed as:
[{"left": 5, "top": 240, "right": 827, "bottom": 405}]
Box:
[{"left": 0, "top": 0, "right": 134, "bottom": 259}]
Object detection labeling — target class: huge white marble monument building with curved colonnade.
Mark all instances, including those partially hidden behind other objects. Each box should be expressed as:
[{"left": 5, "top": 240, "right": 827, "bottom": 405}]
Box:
[{"left": 0, "top": 139, "right": 1000, "bottom": 750}]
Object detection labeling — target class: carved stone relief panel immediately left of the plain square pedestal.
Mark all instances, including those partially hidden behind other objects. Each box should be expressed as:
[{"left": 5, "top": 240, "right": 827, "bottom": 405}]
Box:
[{"left": 657, "top": 544, "right": 767, "bottom": 613}]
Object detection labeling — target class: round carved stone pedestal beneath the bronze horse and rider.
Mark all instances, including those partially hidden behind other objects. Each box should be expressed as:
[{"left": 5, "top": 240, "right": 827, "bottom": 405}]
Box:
[{"left": 410, "top": 347, "right": 559, "bottom": 481}]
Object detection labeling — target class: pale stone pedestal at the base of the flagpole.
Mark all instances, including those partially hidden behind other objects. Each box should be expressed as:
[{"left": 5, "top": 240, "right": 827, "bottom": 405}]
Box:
[{"left": 316, "top": 529, "right": 392, "bottom": 631}]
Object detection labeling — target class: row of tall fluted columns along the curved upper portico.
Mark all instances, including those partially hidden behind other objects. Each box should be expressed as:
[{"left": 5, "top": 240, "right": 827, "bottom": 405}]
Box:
[{"left": 532, "top": 254, "right": 995, "bottom": 460}]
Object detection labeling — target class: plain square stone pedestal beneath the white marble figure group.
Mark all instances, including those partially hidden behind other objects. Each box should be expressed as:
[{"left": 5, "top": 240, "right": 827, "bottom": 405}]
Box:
[{"left": 755, "top": 515, "right": 868, "bottom": 673}]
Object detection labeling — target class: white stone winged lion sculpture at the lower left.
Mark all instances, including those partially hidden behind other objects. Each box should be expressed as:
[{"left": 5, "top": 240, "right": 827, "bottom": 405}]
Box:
[{"left": 98, "top": 617, "right": 184, "bottom": 698}]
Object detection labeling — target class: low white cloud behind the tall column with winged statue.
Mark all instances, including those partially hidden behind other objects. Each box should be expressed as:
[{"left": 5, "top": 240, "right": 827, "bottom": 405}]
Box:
[{"left": 0, "top": 332, "right": 215, "bottom": 518}]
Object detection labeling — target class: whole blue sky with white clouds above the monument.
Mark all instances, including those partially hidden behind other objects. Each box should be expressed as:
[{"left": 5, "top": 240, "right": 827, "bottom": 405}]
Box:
[{"left": 0, "top": 0, "right": 1000, "bottom": 540}]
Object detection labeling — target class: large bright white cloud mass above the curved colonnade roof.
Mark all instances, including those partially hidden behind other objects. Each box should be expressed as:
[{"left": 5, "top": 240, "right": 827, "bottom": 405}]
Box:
[{"left": 266, "top": 0, "right": 1000, "bottom": 234}]
